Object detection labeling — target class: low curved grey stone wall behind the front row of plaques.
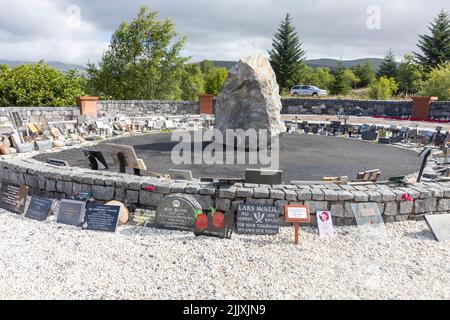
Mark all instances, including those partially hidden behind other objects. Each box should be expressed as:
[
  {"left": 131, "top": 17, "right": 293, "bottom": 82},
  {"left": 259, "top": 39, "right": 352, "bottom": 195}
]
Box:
[{"left": 0, "top": 139, "right": 450, "bottom": 225}]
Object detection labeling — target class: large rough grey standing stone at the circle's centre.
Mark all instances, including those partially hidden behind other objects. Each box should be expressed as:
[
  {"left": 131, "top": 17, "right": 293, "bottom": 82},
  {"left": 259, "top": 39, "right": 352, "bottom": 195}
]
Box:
[{"left": 215, "top": 53, "right": 286, "bottom": 147}]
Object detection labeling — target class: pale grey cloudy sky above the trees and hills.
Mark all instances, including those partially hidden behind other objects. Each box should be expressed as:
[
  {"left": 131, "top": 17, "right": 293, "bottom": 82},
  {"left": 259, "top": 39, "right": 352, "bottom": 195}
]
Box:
[{"left": 0, "top": 0, "right": 450, "bottom": 65}]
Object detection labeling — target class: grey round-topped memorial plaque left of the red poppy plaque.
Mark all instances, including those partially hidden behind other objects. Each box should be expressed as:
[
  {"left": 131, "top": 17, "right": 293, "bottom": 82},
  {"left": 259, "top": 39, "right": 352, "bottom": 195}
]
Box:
[{"left": 156, "top": 194, "right": 202, "bottom": 231}]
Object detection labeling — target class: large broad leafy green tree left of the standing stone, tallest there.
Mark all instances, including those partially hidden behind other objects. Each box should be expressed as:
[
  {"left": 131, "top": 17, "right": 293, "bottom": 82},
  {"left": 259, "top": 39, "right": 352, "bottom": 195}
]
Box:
[{"left": 87, "top": 7, "right": 187, "bottom": 100}]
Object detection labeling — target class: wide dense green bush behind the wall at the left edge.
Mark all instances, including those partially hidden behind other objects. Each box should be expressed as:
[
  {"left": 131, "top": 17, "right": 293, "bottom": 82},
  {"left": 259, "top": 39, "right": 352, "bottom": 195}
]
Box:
[{"left": 0, "top": 61, "right": 84, "bottom": 107}]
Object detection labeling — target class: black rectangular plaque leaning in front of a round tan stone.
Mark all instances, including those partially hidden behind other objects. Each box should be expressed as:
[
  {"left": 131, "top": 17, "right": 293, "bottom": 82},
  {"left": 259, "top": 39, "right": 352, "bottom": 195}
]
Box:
[{"left": 82, "top": 204, "right": 120, "bottom": 232}]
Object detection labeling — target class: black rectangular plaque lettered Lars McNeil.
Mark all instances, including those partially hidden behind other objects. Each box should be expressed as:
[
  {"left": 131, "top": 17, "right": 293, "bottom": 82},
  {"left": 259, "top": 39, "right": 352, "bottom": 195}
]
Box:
[{"left": 236, "top": 204, "right": 279, "bottom": 235}]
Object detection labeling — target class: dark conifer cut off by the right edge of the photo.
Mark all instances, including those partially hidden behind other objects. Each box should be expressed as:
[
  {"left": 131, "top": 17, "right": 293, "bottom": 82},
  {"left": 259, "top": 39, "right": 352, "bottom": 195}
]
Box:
[{"left": 414, "top": 10, "right": 450, "bottom": 70}]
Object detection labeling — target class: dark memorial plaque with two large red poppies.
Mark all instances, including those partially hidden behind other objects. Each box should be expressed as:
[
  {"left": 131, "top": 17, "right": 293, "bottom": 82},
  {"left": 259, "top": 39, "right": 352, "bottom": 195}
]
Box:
[{"left": 194, "top": 210, "right": 234, "bottom": 239}]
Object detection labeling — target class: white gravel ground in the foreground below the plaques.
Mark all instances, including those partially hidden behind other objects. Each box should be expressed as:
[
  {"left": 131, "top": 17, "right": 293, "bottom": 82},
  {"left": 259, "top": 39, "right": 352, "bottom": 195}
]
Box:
[{"left": 0, "top": 210, "right": 450, "bottom": 299}]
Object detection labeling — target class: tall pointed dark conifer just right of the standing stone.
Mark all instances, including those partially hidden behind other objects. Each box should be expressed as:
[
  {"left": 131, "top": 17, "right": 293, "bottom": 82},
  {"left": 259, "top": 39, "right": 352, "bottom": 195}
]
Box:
[{"left": 269, "top": 14, "right": 305, "bottom": 91}]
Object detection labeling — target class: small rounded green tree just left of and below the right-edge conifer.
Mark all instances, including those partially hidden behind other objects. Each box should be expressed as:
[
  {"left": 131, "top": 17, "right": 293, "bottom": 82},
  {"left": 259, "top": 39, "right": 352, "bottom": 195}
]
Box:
[{"left": 397, "top": 54, "right": 424, "bottom": 95}]
